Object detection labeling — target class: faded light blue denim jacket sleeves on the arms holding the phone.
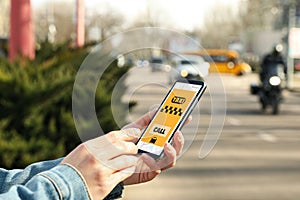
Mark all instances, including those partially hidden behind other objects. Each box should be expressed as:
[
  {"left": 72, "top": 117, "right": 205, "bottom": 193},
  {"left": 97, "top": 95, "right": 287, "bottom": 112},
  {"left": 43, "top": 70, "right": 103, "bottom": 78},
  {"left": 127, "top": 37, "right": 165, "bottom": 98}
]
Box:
[{"left": 0, "top": 158, "right": 123, "bottom": 200}]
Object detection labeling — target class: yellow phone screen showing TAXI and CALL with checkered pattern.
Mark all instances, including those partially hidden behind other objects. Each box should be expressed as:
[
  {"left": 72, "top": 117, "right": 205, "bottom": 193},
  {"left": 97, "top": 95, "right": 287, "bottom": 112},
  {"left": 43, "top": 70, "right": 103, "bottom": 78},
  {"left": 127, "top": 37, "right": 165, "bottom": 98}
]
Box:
[{"left": 138, "top": 82, "right": 201, "bottom": 155}]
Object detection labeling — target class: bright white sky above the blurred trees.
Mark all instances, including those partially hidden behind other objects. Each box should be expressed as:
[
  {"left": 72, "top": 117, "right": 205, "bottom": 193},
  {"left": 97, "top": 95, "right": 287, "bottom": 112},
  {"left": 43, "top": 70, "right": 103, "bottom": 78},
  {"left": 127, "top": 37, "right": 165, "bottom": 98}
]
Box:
[{"left": 31, "top": 0, "right": 241, "bottom": 30}]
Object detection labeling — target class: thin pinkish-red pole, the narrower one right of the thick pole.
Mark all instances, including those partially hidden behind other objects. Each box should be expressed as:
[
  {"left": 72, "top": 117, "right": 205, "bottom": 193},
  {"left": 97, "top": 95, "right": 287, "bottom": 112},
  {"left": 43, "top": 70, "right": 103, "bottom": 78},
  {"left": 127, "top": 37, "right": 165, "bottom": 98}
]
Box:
[{"left": 76, "top": 0, "right": 85, "bottom": 47}]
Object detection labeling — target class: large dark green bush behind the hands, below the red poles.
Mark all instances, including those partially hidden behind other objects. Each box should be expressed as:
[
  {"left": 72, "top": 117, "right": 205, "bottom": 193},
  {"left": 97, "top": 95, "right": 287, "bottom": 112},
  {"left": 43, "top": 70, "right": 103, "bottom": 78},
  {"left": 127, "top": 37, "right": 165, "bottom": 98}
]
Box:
[{"left": 0, "top": 43, "right": 128, "bottom": 168}]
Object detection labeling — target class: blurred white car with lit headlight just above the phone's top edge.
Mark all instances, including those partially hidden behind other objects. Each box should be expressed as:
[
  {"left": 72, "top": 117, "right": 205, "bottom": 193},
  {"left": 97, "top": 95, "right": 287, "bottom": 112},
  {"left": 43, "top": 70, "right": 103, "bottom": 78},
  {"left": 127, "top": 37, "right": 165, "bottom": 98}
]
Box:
[{"left": 168, "top": 55, "right": 209, "bottom": 84}]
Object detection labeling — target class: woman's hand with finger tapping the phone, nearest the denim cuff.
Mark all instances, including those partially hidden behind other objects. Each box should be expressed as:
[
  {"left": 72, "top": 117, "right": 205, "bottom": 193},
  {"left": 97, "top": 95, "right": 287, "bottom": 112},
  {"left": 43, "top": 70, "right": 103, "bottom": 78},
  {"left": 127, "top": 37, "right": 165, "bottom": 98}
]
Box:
[{"left": 61, "top": 128, "right": 141, "bottom": 199}]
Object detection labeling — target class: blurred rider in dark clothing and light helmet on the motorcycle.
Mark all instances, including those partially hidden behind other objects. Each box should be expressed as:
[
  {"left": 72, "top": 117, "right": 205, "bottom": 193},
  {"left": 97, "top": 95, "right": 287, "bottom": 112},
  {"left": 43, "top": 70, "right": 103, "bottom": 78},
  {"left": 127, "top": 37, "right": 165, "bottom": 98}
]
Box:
[{"left": 259, "top": 44, "right": 287, "bottom": 83}]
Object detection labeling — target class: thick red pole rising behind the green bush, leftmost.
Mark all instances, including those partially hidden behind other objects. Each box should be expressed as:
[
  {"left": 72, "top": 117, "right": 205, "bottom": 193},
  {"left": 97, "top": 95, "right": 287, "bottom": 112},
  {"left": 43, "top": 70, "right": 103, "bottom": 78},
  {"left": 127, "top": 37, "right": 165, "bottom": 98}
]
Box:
[{"left": 8, "top": 0, "right": 35, "bottom": 60}]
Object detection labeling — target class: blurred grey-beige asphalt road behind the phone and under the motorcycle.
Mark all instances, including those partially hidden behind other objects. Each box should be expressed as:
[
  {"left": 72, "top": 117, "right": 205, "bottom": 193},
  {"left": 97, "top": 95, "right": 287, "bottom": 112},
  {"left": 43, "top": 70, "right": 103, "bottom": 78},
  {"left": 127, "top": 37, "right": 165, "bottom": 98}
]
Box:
[{"left": 123, "top": 68, "right": 300, "bottom": 200}]
